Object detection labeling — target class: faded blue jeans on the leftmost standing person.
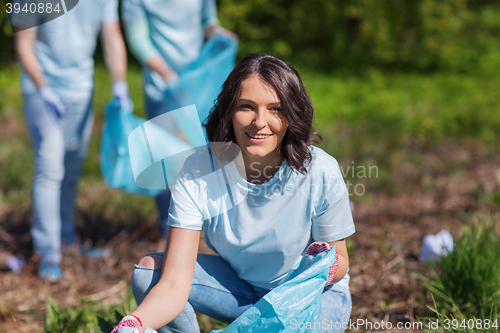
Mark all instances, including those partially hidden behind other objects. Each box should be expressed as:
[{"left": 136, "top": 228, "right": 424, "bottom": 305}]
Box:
[{"left": 23, "top": 93, "right": 94, "bottom": 263}]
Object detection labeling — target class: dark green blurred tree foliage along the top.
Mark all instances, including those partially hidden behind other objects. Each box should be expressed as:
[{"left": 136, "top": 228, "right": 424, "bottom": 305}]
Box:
[{"left": 0, "top": 0, "right": 500, "bottom": 72}]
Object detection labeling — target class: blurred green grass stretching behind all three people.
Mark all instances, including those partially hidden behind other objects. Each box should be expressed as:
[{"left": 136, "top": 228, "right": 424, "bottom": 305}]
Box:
[{"left": 0, "top": 64, "right": 500, "bottom": 209}]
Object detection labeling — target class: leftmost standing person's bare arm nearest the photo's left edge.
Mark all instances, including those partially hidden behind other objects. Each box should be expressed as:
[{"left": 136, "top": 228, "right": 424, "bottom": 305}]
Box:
[{"left": 15, "top": 27, "right": 46, "bottom": 88}]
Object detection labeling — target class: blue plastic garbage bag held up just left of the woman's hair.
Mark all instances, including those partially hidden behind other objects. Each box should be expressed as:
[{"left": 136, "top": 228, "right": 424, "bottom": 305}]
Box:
[{"left": 164, "top": 35, "right": 238, "bottom": 138}]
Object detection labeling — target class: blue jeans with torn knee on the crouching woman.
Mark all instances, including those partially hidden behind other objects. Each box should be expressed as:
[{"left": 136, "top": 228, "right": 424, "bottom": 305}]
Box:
[{"left": 132, "top": 254, "right": 351, "bottom": 333}]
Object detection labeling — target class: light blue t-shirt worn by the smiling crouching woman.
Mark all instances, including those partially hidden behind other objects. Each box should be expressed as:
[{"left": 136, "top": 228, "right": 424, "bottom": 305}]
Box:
[{"left": 169, "top": 147, "right": 355, "bottom": 291}]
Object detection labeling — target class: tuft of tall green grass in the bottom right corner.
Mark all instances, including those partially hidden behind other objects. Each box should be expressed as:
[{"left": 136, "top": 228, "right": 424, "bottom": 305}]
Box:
[{"left": 423, "top": 214, "right": 500, "bottom": 318}]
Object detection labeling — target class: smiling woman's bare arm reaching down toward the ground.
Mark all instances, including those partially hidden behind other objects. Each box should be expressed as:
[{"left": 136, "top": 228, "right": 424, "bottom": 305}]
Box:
[{"left": 133, "top": 227, "right": 200, "bottom": 329}]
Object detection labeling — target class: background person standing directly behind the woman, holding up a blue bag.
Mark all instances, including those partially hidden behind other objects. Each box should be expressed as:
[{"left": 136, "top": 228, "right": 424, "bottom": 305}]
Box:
[{"left": 122, "top": 0, "right": 237, "bottom": 240}]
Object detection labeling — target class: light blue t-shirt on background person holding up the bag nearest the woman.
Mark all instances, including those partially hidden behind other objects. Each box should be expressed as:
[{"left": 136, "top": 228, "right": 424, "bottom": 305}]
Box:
[{"left": 122, "top": 0, "right": 217, "bottom": 101}]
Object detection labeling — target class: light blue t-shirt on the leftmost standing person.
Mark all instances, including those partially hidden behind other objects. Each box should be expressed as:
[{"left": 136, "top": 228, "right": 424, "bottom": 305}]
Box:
[{"left": 12, "top": 0, "right": 118, "bottom": 100}]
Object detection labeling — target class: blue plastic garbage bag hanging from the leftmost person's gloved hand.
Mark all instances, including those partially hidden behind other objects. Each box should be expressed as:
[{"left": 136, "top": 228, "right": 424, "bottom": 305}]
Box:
[{"left": 100, "top": 100, "right": 166, "bottom": 196}]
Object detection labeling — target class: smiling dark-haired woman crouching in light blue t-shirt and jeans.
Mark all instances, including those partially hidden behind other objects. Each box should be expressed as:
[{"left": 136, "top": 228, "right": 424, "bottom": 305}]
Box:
[{"left": 115, "top": 55, "right": 354, "bottom": 332}]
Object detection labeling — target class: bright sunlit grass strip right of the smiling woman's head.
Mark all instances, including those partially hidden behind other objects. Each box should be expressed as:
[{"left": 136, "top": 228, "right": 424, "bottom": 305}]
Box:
[{"left": 303, "top": 70, "right": 500, "bottom": 155}]
